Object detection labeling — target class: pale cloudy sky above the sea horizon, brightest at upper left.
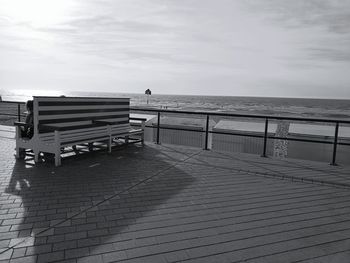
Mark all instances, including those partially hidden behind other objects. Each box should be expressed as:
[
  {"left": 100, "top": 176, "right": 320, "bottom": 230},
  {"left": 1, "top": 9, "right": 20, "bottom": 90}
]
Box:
[{"left": 0, "top": 0, "right": 350, "bottom": 99}]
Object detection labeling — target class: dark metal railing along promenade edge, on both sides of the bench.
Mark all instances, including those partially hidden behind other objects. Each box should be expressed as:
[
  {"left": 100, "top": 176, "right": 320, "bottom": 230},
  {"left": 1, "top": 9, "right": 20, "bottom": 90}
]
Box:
[{"left": 0, "top": 101, "right": 350, "bottom": 165}]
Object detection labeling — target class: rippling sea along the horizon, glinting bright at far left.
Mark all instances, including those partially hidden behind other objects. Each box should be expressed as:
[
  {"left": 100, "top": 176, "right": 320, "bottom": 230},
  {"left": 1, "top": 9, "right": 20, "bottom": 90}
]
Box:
[{"left": 0, "top": 90, "right": 350, "bottom": 119}]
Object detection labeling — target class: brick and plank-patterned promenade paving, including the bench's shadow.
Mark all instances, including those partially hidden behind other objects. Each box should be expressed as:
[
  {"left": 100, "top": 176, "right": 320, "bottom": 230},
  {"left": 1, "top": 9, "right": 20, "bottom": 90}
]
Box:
[{"left": 0, "top": 128, "right": 350, "bottom": 263}]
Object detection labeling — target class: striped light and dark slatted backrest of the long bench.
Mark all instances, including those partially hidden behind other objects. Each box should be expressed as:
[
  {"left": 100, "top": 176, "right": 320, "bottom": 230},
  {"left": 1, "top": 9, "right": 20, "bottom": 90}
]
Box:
[{"left": 34, "top": 97, "right": 130, "bottom": 134}]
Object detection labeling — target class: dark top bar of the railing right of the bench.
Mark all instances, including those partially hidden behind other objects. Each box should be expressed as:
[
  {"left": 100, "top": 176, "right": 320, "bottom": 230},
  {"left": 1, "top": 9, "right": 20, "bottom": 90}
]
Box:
[{"left": 130, "top": 107, "right": 350, "bottom": 124}]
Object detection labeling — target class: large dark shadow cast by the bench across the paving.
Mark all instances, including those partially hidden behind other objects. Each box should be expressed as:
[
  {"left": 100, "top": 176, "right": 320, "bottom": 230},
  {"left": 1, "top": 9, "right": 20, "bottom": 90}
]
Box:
[{"left": 6, "top": 145, "right": 195, "bottom": 262}]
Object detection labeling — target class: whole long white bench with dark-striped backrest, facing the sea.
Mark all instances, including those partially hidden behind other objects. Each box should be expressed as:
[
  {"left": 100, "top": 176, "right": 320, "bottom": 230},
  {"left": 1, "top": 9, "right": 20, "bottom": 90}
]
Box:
[{"left": 15, "top": 97, "right": 144, "bottom": 166}]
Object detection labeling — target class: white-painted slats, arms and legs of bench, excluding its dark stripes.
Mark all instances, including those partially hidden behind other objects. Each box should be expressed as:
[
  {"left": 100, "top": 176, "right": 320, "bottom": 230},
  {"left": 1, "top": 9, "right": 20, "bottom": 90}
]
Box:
[{"left": 16, "top": 97, "right": 145, "bottom": 166}]
